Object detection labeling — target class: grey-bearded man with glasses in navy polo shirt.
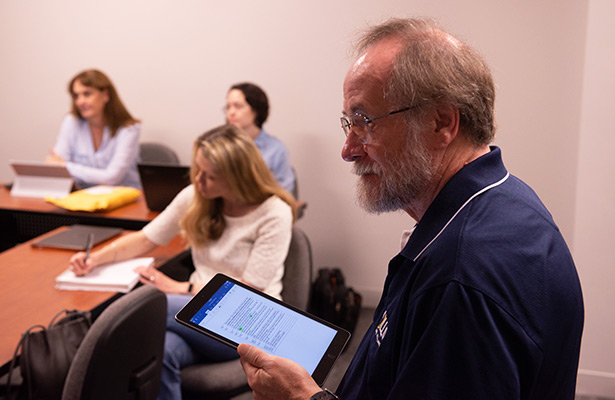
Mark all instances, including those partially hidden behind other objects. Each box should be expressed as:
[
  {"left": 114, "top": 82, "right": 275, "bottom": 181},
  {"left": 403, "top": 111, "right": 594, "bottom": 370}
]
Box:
[{"left": 238, "top": 19, "right": 584, "bottom": 400}]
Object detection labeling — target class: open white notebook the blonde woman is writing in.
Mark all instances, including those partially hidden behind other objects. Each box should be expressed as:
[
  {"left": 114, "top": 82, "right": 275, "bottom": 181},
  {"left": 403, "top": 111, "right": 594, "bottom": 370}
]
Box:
[{"left": 56, "top": 257, "right": 154, "bottom": 293}]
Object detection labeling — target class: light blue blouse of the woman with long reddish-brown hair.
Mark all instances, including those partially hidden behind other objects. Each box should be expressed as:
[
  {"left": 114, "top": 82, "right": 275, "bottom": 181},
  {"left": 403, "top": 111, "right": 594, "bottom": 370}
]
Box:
[{"left": 53, "top": 114, "right": 141, "bottom": 189}]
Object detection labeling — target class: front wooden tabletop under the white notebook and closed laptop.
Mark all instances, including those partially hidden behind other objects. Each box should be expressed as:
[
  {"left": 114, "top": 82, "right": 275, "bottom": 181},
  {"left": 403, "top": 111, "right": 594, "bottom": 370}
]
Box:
[{"left": 0, "top": 227, "right": 184, "bottom": 365}]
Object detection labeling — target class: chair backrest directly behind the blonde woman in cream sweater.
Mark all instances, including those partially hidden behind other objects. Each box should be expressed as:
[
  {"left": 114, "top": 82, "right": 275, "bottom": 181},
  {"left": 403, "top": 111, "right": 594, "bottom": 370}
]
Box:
[{"left": 282, "top": 226, "right": 312, "bottom": 310}]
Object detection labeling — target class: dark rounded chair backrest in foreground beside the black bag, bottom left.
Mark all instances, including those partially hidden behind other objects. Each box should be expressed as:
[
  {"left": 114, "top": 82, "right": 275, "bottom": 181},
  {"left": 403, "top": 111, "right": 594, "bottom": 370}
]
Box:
[{"left": 62, "top": 286, "right": 167, "bottom": 400}]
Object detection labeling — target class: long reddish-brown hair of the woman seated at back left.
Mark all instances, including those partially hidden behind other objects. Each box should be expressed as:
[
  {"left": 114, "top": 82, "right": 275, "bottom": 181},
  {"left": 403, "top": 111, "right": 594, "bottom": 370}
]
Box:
[{"left": 68, "top": 69, "right": 139, "bottom": 137}]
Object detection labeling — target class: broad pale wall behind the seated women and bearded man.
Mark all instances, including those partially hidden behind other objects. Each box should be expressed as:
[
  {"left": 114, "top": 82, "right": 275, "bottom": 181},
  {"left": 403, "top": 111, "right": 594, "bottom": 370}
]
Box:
[{"left": 0, "top": 0, "right": 615, "bottom": 394}]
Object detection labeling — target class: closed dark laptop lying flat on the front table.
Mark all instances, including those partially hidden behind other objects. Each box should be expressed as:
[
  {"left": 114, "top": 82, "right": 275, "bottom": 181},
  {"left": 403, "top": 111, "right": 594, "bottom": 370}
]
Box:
[{"left": 32, "top": 225, "right": 122, "bottom": 251}]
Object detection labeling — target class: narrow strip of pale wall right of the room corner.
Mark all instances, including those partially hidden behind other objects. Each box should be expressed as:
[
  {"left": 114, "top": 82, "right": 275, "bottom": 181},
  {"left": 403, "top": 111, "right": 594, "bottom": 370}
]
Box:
[{"left": 573, "top": 0, "right": 615, "bottom": 397}]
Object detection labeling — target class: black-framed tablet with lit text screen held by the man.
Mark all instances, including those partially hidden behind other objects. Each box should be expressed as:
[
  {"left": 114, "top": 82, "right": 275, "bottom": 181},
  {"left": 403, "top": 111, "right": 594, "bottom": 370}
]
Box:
[{"left": 175, "top": 274, "right": 350, "bottom": 385}]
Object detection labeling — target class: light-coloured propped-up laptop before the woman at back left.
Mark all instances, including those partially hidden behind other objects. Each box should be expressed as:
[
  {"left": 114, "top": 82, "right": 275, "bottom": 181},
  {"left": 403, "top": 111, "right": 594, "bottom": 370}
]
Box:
[{"left": 9, "top": 160, "right": 74, "bottom": 198}]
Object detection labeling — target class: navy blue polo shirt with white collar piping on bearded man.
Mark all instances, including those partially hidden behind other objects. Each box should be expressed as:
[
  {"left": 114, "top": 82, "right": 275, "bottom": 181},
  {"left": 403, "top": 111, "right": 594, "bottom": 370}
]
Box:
[{"left": 338, "top": 147, "right": 583, "bottom": 400}]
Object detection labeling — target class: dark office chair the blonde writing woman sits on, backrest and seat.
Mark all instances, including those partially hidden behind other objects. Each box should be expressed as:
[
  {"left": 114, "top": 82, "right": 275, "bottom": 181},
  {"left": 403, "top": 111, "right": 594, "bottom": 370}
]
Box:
[{"left": 181, "top": 227, "right": 312, "bottom": 399}]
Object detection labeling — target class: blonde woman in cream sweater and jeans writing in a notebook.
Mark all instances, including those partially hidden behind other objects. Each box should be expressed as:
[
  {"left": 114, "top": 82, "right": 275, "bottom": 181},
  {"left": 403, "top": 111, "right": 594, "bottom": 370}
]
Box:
[{"left": 71, "top": 125, "right": 295, "bottom": 399}]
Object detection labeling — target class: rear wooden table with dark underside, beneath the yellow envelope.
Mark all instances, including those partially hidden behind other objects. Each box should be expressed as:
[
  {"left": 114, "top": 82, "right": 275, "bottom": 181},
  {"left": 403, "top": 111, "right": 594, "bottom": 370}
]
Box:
[{"left": 0, "top": 186, "right": 158, "bottom": 250}]
